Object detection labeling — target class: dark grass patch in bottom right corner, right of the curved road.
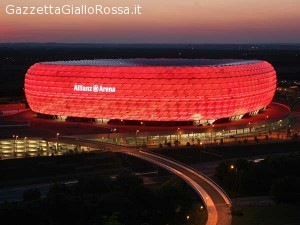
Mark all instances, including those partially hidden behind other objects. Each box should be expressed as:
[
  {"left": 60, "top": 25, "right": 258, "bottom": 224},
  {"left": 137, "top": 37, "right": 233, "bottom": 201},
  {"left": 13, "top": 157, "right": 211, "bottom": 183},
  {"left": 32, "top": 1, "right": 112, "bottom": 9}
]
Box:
[{"left": 232, "top": 204, "right": 300, "bottom": 225}]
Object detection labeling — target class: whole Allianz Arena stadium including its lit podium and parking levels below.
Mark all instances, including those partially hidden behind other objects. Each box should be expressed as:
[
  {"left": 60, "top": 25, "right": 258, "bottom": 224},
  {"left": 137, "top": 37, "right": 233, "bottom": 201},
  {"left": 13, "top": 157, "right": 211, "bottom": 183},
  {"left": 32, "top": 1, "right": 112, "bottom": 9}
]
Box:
[{"left": 0, "top": 59, "right": 293, "bottom": 158}]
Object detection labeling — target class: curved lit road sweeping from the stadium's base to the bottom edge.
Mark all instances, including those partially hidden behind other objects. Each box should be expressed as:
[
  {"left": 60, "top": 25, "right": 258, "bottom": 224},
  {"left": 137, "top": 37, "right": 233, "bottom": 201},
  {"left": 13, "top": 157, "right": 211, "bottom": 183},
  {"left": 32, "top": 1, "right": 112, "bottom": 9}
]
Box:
[{"left": 59, "top": 137, "right": 232, "bottom": 225}]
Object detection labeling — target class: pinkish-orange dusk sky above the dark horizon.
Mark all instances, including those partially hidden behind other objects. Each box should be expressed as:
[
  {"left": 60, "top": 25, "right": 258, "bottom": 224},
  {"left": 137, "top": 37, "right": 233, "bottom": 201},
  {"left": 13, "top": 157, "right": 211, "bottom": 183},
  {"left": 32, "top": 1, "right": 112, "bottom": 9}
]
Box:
[{"left": 0, "top": 0, "right": 300, "bottom": 43}]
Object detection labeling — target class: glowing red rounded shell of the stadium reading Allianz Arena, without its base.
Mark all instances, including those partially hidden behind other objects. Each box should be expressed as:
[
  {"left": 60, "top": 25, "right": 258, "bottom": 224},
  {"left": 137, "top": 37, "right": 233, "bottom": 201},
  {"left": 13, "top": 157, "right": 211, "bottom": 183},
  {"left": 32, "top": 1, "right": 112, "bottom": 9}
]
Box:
[{"left": 25, "top": 59, "right": 276, "bottom": 121}]
